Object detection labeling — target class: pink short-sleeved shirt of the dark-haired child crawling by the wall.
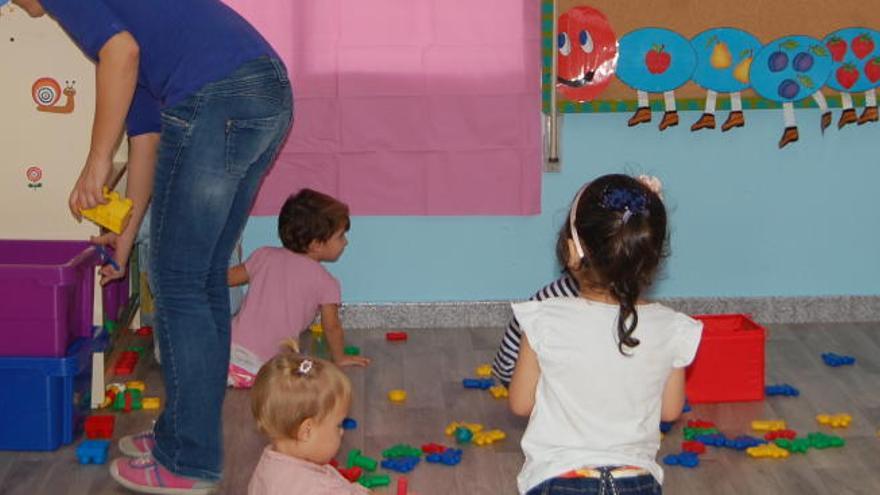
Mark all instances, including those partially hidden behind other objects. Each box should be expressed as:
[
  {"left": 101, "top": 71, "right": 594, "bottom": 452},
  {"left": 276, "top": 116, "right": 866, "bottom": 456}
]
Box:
[{"left": 232, "top": 247, "right": 340, "bottom": 362}]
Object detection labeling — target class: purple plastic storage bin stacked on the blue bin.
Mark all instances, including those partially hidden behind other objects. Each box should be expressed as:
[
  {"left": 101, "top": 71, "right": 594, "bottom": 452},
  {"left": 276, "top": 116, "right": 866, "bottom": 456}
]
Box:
[{"left": 0, "top": 240, "right": 100, "bottom": 357}]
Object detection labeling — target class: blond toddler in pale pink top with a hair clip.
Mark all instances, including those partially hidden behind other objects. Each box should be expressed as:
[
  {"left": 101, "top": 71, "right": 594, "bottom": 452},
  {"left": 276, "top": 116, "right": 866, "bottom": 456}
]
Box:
[{"left": 248, "top": 352, "right": 369, "bottom": 495}]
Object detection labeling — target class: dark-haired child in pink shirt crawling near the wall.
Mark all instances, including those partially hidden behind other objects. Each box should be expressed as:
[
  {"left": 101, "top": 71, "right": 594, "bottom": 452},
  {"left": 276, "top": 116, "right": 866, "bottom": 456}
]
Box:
[{"left": 228, "top": 189, "right": 369, "bottom": 388}]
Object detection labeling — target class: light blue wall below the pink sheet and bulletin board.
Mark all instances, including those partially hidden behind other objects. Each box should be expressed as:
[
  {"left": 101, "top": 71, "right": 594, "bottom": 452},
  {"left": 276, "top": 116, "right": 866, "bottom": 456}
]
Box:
[{"left": 244, "top": 109, "right": 880, "bottom": 303}]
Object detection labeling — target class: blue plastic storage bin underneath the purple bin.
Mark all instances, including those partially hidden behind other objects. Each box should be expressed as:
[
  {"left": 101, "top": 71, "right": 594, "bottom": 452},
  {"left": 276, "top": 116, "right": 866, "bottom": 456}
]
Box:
[{"left": 0, "top": 338, "right": 97, "bottom": 450}]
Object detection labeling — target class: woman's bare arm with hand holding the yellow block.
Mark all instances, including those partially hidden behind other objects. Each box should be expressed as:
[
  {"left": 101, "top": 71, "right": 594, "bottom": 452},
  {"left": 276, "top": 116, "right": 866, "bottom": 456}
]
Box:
[{"left": 68, "top": 31, "right": 140, "bottom": 220}]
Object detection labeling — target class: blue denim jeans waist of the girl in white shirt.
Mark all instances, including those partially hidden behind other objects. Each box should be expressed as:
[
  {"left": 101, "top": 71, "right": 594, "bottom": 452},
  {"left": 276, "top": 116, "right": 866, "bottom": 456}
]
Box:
[{"left": 526, "top": 468, "right": 663, "bottom": 495}]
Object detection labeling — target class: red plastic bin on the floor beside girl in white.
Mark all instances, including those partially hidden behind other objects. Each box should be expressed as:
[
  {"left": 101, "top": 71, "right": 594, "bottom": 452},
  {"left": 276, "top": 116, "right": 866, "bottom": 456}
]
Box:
[{"left": 686, "top": 314, "right": 767, "bottom": 403}]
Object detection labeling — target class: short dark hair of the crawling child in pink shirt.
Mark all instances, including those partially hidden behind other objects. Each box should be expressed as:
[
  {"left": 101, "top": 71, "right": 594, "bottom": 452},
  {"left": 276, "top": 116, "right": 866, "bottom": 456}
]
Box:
[{"left": 278, "top": 189, "right": 351, "bottom": 253}]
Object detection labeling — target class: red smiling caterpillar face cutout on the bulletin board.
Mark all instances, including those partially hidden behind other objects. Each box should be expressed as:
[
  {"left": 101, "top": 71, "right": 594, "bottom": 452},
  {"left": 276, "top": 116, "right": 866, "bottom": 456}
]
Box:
[{"left": 556, "top": 7, "right": 617, "bottom": 101}]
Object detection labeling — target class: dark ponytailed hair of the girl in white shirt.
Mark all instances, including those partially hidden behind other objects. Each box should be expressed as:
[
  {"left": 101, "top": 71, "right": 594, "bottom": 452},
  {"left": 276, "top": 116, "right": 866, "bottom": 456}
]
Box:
[{"left": 556, "top": 174, "right": 667, "bottom": 354}]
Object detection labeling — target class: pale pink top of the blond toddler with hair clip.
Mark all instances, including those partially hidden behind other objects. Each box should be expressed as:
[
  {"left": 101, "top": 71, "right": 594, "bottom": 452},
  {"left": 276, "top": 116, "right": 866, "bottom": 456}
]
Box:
[{"left": 248, "top": 446, "right": 370, "bottom": 495}]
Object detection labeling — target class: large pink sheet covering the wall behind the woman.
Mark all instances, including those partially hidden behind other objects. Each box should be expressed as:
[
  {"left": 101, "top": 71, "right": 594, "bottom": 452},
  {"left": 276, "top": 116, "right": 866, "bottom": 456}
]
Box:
[{"left": 226, "top": 0, "right": 541, "bottom": 215}]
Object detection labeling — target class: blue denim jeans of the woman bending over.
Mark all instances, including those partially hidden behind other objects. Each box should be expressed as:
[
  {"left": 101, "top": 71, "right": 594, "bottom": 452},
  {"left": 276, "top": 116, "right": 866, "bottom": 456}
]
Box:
[{"left": 149, "top": 57, "right": 293, "bottom": 480}]
